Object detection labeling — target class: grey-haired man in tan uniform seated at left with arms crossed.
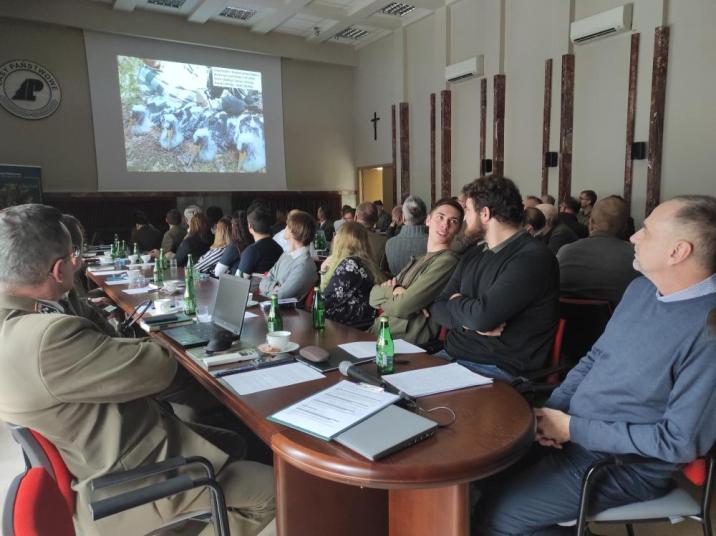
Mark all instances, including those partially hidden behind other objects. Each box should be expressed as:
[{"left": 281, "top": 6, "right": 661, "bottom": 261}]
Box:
[{"left": 0, "top": 205, "right": 275, "bottom": 536}]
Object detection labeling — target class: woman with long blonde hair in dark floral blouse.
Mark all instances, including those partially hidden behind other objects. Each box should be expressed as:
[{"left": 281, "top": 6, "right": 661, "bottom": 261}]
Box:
[{"left": 321, "top": 222, "right": 384, "bottom": 325}]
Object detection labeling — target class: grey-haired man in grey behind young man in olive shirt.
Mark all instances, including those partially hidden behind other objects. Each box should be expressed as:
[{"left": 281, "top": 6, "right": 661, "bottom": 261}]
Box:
[{"left": 383, "top": 195, "right": 428, "bottom": 274}]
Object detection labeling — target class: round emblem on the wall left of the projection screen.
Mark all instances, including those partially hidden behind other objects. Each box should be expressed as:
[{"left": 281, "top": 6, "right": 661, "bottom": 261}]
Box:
[{"left": 0, "top": 60, "right": 62, "bottom": 119}]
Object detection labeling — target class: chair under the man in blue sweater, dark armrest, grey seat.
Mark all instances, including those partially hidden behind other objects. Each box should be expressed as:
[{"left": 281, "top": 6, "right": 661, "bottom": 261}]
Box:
[{"left": 576, "top": 446, "right": 716, "bottom": 536}]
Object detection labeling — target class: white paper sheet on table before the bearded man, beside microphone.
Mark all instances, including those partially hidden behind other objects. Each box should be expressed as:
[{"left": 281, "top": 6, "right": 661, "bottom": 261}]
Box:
[{"left": 383, "top": 363, "right": 492, "bottom": 397}]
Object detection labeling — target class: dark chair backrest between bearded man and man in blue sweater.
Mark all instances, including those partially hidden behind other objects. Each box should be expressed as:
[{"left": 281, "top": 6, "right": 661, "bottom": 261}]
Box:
[{"left": 559, "top": 297, "right": 613, "bottom": 363}]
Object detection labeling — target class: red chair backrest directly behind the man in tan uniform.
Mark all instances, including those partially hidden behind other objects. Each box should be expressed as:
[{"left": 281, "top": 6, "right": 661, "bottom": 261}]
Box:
[{"left": 10, "top": 425, "right": 75, "bottom": 515}]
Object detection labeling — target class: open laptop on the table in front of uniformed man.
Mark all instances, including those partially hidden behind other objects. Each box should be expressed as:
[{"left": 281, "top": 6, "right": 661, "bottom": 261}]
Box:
[{"left": 161, "top": 274, "right": 250, "bottom": 348}]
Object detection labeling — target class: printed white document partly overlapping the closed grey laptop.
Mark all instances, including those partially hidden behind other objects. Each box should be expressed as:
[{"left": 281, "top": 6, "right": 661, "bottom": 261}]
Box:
[{"left": 269, "top": 378, "right": 399, "bottom": 441}]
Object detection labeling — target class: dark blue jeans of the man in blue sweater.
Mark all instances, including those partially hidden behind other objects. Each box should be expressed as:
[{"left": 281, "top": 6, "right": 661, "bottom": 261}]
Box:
[{"left": 472, "top": 443, "right": 670, "bottom": 536}]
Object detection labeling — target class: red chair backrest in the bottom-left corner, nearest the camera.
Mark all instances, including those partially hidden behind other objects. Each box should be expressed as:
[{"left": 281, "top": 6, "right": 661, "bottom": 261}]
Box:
[{"left": 2, "top": 467, "right": 75, "bottom": 536}]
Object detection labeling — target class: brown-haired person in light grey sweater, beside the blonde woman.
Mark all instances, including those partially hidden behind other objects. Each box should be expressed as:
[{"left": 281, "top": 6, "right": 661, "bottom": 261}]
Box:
[{"left": 259, "top": 210, "right": 318, "bottom": 300}]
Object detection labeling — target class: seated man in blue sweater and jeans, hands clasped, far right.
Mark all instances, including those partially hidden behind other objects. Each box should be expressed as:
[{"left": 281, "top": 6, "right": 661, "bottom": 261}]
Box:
[{"left": 475, "top": 196, "right": 716, "bottom": 535}]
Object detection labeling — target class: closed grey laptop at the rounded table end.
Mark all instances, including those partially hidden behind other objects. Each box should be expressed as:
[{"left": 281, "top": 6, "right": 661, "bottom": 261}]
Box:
[{"left": 335, "top": 405, "right": 438, "bottom": 460}]
